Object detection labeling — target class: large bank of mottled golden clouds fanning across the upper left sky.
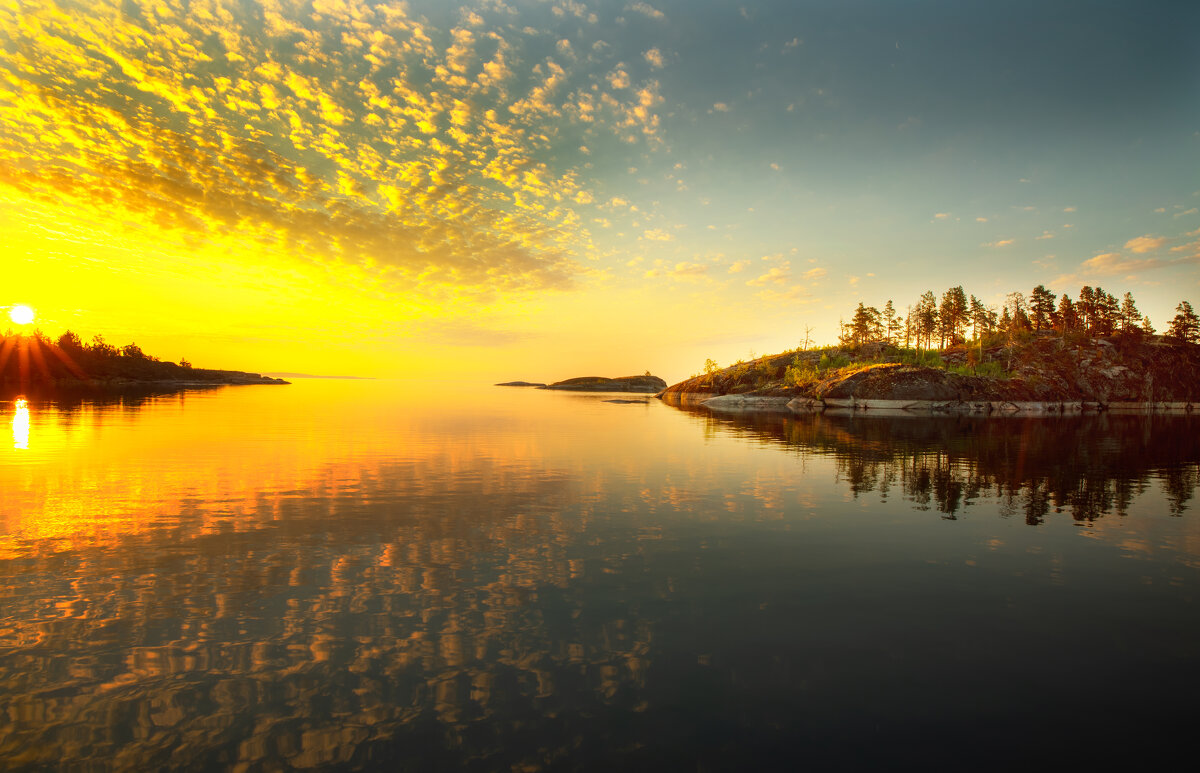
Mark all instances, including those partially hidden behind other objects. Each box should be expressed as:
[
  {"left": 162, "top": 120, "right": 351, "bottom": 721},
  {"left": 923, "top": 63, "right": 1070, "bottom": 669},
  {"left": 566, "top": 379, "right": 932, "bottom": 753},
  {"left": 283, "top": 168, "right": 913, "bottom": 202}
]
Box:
[{"left": 0, "top": 0, "right": 686, "bottom": 307}]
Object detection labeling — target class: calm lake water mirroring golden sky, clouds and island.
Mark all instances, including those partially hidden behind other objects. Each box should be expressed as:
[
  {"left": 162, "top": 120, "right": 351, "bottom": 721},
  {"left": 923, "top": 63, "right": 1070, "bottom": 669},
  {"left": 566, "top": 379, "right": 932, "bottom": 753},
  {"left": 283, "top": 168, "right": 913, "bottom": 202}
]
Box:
[{"left": 0, "top": 380, "right": 1200, "bottom": 771}]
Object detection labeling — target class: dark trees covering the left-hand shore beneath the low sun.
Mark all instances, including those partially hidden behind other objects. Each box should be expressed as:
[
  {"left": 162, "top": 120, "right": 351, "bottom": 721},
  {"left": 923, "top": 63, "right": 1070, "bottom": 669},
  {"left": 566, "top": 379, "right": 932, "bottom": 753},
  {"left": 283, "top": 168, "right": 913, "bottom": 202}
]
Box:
[{"left": 0, "top": 330, "right": 194, "bottom": 383}]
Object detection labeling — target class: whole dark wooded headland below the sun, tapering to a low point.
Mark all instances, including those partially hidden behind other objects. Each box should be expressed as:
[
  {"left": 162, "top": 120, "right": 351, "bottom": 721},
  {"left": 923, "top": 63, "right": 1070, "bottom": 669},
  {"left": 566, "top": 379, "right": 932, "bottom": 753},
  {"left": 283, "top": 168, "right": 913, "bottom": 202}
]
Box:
[{"left": 0, "top": 330, "right": 288, "bottom": 397}]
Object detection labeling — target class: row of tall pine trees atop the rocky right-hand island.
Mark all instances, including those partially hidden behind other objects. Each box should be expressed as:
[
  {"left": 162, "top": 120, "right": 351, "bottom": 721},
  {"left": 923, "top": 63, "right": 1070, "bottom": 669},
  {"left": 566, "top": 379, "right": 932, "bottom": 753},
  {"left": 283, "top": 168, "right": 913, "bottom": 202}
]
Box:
[{"left": 838, "top": 284, "right": 1200, "bottom": 349}]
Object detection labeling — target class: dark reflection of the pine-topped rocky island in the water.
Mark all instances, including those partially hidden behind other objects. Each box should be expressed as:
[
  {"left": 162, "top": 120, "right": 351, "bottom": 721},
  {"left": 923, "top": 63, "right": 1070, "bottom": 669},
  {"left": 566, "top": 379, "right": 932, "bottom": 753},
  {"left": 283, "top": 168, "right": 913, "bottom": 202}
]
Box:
[{"left": 681, "top": 411, "right": 1200, "bottom": 523}]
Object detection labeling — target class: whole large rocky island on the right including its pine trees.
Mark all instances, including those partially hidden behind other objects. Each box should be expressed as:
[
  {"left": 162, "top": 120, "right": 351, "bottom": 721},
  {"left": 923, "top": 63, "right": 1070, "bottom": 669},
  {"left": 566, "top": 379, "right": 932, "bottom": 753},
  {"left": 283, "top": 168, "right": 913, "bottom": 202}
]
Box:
[{"left": 659, "top": 286, "right": 1200, "bottom": 414}]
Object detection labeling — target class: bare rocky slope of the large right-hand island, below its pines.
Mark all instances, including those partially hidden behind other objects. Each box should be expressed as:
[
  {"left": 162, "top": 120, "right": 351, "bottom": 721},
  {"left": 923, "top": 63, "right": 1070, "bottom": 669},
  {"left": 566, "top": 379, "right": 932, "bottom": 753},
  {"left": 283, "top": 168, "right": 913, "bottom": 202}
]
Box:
[{"left": 659, "top": 335, "right": 1200, "bottom": 413}]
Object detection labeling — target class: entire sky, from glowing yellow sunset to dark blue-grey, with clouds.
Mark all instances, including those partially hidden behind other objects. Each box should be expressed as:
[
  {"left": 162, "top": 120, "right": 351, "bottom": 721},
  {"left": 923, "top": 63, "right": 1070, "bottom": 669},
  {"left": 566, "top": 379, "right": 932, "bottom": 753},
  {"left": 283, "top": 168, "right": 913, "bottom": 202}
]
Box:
[{"left": 0, "top": 0, "right": 1200, "bottom": 382}]
